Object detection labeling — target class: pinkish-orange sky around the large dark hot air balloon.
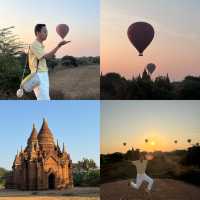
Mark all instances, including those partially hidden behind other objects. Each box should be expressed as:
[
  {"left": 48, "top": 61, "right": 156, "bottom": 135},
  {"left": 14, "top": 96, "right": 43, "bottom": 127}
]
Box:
[{"left": 100, "top": 0, "right": 200, "bottom": 81}]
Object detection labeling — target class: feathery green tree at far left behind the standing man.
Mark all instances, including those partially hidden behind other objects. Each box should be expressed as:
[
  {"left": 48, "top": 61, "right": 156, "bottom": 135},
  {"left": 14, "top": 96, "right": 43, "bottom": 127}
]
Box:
[{"left": 0, "top": 27, "right": 23, "bottom": 94}]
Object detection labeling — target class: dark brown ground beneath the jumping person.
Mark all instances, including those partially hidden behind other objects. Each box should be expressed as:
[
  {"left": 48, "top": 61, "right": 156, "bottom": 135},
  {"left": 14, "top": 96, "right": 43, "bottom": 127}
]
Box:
[{"left": 101, "top": 179, "right": 200, "bottom": 200}]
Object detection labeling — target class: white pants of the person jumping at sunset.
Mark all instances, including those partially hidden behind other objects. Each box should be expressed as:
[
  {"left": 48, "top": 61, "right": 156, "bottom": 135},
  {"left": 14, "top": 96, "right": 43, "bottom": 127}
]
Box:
[{"left": 131, "top": 173, "right": 153, "bottom": 191}]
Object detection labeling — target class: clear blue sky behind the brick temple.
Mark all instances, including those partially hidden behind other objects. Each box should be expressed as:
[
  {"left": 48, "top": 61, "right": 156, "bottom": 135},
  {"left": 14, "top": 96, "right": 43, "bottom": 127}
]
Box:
[{"left": 0, "top": 101, "right": 100, "bottom": 169}]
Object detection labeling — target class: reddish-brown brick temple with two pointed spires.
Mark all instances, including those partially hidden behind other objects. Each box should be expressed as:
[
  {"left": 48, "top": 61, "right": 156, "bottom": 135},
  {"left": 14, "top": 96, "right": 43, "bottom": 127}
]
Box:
[{"left": 6, "top": 119, "right": 73, "bottom": 190}]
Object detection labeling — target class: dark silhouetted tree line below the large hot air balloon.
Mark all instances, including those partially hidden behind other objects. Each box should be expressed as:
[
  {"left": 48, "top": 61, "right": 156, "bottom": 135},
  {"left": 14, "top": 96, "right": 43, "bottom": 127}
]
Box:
[{"left": 100, "top": 69, "right": 200, "bottom": 100}]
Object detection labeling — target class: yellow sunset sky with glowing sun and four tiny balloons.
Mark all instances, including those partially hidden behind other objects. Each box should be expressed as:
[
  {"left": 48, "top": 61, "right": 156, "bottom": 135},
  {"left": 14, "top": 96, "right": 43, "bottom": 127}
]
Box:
[{"left": 101, "top": 101, "right": 200, "bottom": 154}]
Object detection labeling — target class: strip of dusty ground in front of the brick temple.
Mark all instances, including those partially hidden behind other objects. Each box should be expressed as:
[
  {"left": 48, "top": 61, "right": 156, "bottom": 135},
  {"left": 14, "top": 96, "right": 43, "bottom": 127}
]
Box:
[{"left": 0, "top": 187, "right": 100, "bottom": 200}]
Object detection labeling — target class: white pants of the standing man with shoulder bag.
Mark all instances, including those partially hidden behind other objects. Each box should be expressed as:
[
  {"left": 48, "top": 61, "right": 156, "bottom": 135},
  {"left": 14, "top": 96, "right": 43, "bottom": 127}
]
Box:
[{"left": 34, "top": 72, "right": 50, "bottom": 100}]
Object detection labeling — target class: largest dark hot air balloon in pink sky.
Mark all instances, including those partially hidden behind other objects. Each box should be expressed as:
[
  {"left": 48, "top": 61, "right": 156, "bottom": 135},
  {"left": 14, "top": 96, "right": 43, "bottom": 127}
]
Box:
[{"left": 127, "top": 22, "right": 154, "bottom": 56}]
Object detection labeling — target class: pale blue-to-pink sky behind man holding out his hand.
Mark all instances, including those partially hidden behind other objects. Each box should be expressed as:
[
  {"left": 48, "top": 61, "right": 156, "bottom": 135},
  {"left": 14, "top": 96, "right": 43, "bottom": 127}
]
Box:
[{"left": 0, "top": 0, "right": 100, "bottom": 57}]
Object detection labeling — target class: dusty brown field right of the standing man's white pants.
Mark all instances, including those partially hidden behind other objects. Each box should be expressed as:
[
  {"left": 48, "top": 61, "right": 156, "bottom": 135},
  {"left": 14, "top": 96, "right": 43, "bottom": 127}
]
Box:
[{"left": 50, "top": 65, "right": 100, "bottom": 99}]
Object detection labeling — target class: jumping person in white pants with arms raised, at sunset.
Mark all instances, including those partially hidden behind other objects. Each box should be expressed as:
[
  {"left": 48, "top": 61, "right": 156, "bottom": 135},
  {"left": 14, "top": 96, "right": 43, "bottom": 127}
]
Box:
[{"left": 130, "top": 154, "right": 154, "bottom": 192}]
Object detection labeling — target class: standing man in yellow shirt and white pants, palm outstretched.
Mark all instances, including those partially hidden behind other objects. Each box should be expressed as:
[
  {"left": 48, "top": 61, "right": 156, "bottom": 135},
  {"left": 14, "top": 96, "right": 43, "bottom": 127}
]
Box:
[{"left": 29, "top": 24, "right": 70, "bottom": 100}]
